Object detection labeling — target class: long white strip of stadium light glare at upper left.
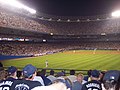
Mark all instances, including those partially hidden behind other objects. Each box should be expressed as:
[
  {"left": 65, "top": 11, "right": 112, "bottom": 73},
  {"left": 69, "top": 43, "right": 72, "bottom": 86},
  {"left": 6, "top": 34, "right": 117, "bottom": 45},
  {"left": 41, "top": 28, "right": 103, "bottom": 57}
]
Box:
[{"left": 0, "top": 0, "right": 36, "bottom": 14}]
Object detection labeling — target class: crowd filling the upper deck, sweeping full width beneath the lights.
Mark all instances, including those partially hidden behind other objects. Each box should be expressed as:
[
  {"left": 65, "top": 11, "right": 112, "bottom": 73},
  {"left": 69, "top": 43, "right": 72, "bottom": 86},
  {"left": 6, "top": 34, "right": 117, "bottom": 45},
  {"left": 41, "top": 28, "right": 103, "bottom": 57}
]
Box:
[{"left": 0, "top": 8, "right": 120, "bottom": 35}]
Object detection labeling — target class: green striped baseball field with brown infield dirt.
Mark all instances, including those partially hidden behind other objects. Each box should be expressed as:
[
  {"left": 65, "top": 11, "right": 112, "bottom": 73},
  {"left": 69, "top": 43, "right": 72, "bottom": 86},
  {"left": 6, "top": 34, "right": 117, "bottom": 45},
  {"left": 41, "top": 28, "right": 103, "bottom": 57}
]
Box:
[{"left": 2, "top": 50, "right": 120, "bottom": 70}]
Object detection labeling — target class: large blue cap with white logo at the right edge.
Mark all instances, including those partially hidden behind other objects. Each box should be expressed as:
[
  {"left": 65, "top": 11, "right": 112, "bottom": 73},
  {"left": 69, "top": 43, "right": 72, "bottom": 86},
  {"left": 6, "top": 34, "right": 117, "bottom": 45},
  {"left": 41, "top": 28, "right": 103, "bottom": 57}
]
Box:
[{"left": 103, "top": 70, "right": 120, "bottom": 81}]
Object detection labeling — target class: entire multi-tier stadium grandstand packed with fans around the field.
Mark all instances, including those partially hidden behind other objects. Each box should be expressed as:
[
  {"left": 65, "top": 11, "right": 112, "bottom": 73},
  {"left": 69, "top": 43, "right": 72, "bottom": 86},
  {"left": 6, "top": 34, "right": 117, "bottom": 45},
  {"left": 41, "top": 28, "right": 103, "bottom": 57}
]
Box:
[{"left": 0, "top": 1, "right": 120, "bottom": 71}]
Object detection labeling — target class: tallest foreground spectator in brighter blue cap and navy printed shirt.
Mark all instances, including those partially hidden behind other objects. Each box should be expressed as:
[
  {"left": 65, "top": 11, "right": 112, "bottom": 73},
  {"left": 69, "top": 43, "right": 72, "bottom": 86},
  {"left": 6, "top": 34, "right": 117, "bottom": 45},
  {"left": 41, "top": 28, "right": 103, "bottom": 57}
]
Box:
[{"left": 11, "top": 64, "right": 42, "bottom": 90}]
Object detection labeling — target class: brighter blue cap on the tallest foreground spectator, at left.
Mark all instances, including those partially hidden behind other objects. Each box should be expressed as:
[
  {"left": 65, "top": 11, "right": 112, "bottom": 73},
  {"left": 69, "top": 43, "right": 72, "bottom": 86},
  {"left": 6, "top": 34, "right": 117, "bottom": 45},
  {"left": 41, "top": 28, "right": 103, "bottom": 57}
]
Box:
[{"left": 23, "top": 64, "right": 37, "bottom": 78}]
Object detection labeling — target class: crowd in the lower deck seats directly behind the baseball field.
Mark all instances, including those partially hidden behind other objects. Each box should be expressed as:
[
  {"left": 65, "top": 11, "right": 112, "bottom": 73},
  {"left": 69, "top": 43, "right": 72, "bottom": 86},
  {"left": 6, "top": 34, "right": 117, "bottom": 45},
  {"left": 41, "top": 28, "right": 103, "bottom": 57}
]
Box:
[{"left": 0, "top": 42, "right": 120, "bottom": 56}]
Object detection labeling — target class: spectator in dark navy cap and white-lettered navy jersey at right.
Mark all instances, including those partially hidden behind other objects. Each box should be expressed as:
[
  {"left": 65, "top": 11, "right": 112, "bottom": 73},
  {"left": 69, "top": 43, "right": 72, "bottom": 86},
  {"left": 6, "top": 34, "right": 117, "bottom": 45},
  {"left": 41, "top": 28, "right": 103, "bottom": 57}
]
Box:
[{"left": 81, "top": 70, "right": 102, "bottom": 90}]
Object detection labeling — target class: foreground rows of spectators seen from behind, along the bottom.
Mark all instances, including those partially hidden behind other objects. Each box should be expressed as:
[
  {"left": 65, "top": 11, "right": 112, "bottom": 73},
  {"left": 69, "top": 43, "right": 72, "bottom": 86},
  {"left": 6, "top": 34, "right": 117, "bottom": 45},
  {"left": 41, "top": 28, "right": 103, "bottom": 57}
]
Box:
[{"left": 0, "top": 64, "right": 120, "bottom": 90}]
